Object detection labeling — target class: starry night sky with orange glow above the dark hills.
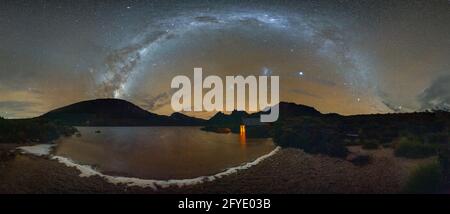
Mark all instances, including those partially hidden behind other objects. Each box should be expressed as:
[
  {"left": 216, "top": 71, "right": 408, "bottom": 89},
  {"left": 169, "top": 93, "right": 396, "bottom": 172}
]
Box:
[{"left": 0, "top": 0, "right": 450, "bottom": 118}]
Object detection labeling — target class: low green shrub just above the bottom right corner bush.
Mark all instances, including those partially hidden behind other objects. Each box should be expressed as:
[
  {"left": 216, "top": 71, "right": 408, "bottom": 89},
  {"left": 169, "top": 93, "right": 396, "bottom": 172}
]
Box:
[{"left": 394, "top": 137, "right": 436, "bottom": 158}]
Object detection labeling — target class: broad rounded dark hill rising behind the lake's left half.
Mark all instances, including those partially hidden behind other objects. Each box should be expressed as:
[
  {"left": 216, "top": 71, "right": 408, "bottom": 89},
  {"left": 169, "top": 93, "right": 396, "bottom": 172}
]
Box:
[{"left": 40, "top": 99, "right": 205, "bottom": 126}]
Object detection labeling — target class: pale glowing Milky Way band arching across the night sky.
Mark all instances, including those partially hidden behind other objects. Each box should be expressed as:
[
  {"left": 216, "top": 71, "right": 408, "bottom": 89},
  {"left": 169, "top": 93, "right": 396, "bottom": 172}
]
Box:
[{"left": 96, "top": 10, "right": 376, "bottom": 105}]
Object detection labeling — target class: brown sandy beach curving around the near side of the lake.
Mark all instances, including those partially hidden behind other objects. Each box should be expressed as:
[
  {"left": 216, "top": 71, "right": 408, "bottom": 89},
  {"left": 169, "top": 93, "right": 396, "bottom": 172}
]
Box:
[{"left": 0, "top": 145, "right": 433, "bottom": 194}]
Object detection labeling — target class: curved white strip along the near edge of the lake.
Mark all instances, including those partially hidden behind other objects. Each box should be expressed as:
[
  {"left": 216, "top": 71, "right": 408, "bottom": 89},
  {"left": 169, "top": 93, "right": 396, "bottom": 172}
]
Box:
[{"left": 18, "top": 144, "right": 280, "bottom": 190}]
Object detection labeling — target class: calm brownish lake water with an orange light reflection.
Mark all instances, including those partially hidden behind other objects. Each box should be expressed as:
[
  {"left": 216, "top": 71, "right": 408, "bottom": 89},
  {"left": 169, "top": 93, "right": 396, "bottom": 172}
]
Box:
[{"left": 55, "top": 127, "right": 275, "bottom": 179}]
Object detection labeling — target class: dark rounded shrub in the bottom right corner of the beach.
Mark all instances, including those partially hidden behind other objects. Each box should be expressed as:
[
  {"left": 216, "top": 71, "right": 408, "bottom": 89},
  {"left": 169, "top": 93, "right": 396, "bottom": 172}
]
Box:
[{"left": 404, "top": 162, "right": 442, "bottom": 193}]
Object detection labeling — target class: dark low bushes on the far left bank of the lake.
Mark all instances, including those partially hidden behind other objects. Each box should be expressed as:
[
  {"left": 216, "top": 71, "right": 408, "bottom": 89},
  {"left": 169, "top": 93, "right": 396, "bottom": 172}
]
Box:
[{"left": 0, "top": 118, "right": 77, "bottom": 143}]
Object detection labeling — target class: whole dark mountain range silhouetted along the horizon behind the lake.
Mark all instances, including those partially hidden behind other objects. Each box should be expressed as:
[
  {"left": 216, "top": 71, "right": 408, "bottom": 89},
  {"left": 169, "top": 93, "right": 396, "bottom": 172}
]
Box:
[{"left": 39, "top": 99, "right": 322, "bottom": 129}]
